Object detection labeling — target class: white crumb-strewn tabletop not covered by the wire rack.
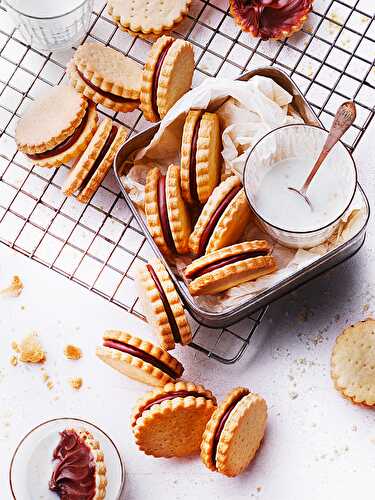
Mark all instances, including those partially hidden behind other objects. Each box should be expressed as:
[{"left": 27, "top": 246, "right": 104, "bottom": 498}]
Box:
[{"left": 0, "top": 118, "right": 375, "bottom": 500}]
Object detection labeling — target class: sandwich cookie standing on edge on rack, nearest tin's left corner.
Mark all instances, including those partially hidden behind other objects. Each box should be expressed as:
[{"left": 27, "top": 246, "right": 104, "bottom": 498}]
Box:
[{"left": 61, "top": 118, "right": 128, "bottom": 203}]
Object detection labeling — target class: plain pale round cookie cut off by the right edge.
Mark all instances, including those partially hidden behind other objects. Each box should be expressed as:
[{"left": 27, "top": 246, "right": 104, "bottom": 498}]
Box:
[{"left": 331, "top": 318, "right": 375, "bottom": 407}]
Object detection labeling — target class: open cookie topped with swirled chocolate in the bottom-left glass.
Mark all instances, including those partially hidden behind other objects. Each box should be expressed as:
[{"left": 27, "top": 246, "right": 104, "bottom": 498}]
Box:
[{"left": 49, "top": 429, "right": 107, "bottom": 500}]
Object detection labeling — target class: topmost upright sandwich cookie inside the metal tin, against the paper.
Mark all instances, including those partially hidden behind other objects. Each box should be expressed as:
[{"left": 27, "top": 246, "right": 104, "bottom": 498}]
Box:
[{"left": 181, "top": 110, "right": 221, "bottom": 204}]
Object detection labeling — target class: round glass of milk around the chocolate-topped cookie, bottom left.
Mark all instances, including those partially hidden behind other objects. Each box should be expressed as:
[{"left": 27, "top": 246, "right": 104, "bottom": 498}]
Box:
[{"left": 9, "top": 418, "right": 125, "bottom": 500}]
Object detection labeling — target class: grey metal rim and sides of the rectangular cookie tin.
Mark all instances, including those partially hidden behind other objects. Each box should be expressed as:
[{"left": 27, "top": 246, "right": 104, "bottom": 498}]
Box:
[{"left": 114, "top": 66, "right": 370, "bottom": 328}]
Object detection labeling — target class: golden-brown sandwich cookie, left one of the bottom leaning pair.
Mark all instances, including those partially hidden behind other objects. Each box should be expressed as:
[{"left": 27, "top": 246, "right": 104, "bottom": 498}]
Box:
[{"left": 131, "top": 381, "right": 216, "bottom": 458}]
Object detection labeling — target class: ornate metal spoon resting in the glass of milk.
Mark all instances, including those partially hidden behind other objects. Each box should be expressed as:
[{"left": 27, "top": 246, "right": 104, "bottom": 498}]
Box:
[{"left": 288, "top": 101, "right": 356, "bottom": 210}]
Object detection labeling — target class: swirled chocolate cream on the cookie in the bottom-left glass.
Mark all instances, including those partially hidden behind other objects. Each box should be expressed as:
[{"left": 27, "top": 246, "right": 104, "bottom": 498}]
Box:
[{"left": 49, "top": 429, "right": 96, "bottom": 500}]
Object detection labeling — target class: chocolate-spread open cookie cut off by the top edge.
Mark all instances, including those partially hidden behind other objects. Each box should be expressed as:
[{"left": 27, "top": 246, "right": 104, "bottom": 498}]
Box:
[{"left": 232, "top": 0, "right": 312, "bottom": 40}]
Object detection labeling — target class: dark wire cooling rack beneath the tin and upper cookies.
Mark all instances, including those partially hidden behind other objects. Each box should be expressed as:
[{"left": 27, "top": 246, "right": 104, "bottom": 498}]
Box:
[{"left": 0, "top": 0, "right": 375, "bottom": 363}]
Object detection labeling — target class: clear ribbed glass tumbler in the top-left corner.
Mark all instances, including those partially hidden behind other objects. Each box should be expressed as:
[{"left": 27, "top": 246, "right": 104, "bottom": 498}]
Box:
[{"left": 3, "top": 0, "right": 93, "bottom": 52}]
